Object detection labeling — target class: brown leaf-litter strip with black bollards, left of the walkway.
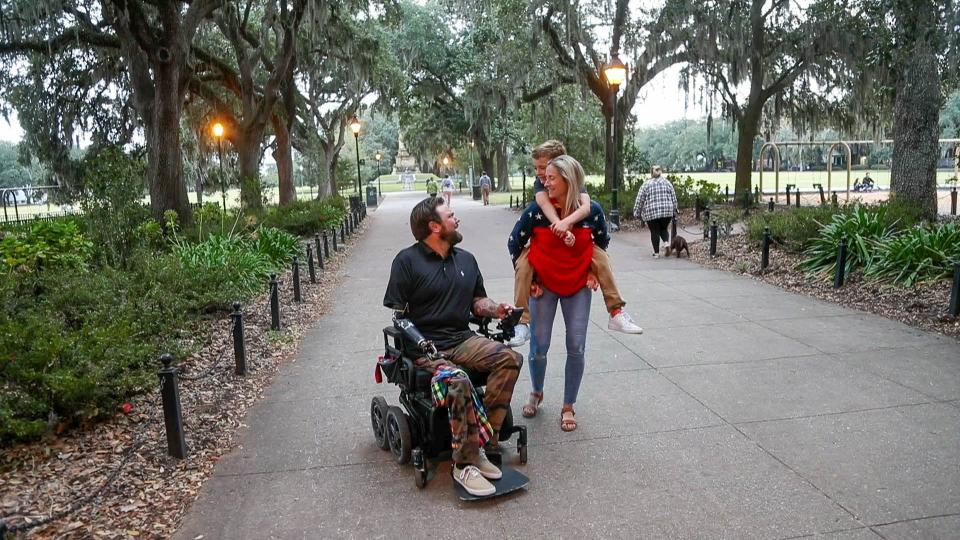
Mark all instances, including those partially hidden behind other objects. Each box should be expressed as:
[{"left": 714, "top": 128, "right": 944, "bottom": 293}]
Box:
[{"left": 0, "top": 218, "right": 364, "bottom": 539}]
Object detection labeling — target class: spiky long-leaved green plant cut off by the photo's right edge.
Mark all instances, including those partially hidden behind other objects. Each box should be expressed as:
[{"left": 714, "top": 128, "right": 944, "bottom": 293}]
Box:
[{"left": 865, "top": 223, "right": 960, "bottom": 287}]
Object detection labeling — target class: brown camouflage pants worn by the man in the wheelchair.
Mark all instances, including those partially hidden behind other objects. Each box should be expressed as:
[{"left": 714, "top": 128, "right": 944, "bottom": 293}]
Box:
[{"left": 417, "top": 336, "right": 523, "bottom": 463}]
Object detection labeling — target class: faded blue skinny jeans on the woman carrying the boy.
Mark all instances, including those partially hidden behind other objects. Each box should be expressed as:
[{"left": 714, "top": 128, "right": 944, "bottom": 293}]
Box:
[{"left": 527, "top": 287, "right": 593, "bottom": 405}]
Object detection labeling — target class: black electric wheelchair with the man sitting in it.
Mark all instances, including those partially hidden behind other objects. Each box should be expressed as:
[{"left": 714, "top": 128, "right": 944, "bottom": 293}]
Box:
[{"left": 370, "top": 309, "right": 527, "bottom": 488}]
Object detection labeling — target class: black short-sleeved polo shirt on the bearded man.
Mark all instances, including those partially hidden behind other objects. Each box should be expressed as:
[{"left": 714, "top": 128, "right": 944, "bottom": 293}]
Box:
[{"left": 383, "top": 242, "right": 487, "bottom": 349}]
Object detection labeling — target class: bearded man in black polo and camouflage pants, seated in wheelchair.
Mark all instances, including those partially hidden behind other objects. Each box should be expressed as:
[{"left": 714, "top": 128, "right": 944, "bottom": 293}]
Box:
[{"left": 383, "top": 197, "right": 523, "bottom": 495}]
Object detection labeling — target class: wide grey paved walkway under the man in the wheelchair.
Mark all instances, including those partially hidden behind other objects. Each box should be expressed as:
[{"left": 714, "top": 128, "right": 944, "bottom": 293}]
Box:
[{"left": 176, "top": 190, "right": 960, "bottom": 540}]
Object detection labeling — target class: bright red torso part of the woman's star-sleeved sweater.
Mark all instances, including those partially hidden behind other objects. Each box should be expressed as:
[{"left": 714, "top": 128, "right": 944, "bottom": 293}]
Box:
[{"left": 528, "top": 227, "right": 593, "bottom": 296}]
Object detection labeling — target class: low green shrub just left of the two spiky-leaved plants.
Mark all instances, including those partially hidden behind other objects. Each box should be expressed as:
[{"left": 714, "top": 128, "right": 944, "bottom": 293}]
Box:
[{"left": 746, "top": 205, "right": 843, "bottom": 252}]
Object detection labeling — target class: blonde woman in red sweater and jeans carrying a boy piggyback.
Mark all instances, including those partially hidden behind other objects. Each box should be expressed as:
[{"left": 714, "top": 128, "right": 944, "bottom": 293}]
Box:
[{"left": 508, "top": 155, "right": 610, "bottom": 431}]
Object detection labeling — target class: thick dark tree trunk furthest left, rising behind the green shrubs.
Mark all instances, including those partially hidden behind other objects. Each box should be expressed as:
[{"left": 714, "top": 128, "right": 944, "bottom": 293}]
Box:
[{"left": 150, "top": 61, "right": 192, "bottom": 224}]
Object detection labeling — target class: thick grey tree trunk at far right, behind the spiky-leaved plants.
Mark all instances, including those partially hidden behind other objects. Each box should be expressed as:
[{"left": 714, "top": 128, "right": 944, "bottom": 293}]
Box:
[{"left": 890, "top": 14, "right": 942, "bottom": 219}]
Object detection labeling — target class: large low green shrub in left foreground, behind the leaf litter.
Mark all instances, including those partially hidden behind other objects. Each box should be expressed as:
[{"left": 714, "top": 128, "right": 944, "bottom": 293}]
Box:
[{"left": 0, "top": 267, "right": 181, "bottom": 445}]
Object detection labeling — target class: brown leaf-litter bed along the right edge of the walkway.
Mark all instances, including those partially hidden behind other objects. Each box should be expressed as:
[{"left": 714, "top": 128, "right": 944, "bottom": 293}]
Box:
[{"left": 690, "top": 234, "right": 960, "bottom": 339}]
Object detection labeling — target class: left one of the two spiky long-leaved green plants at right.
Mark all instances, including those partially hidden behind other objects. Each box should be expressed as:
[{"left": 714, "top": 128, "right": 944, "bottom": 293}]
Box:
[{"left": 800, "top": 205, "right": 893, "bottom": 273}]
